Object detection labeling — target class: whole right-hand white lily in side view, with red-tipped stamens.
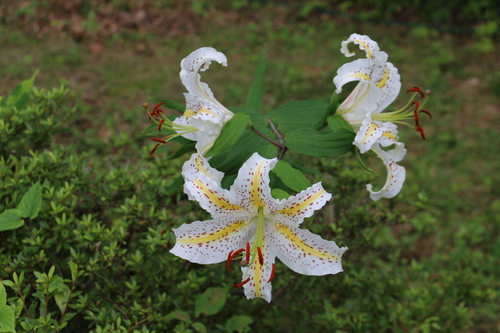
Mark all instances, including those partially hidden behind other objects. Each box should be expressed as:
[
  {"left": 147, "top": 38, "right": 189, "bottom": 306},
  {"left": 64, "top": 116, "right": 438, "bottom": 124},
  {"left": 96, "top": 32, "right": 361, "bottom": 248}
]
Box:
[{"left": 333, "top": 34, "right": 430, "bottom": 200}]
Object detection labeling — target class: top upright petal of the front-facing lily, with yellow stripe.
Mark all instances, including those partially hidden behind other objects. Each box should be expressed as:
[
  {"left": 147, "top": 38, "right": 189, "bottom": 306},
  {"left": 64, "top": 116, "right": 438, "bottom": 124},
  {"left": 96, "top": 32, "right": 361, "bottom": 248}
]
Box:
[{"left": 231, "top": 153, "right": 278, "bottom": 215}]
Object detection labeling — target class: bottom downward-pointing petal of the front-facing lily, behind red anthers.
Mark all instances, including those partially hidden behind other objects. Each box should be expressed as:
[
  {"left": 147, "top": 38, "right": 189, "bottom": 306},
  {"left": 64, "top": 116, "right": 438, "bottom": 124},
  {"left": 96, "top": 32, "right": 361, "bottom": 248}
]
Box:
[{"left": 241, "top": 240, "right": 276, "bottom": 302}]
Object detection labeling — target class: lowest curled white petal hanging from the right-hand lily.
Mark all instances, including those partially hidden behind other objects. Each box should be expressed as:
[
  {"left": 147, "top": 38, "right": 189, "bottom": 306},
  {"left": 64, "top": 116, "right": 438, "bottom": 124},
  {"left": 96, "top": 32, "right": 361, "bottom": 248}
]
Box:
[{"left": 366, "top": 142, "right": 406, "bottom": 201}]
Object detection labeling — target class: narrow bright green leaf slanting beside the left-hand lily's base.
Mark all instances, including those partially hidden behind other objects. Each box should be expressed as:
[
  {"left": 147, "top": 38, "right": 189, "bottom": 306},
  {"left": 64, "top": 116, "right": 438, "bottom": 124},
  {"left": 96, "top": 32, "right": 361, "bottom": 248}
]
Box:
[{"left": 205, "top": 113, "right": 250, "bottom": 158}]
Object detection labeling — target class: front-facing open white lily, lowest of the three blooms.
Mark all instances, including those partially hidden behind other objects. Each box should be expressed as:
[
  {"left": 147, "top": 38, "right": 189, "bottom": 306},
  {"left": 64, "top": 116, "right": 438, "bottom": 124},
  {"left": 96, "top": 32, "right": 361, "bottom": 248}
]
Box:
[{"left": 170, "top": 153, "right": 347, "bottom": 302}]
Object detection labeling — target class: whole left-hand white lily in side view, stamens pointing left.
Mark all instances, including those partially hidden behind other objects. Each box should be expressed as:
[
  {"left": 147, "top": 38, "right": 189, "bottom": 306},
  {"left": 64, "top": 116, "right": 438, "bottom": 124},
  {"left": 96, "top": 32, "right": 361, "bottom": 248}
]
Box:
[{"left": 150, "top": 47, "right": 234, "bottom": 154}]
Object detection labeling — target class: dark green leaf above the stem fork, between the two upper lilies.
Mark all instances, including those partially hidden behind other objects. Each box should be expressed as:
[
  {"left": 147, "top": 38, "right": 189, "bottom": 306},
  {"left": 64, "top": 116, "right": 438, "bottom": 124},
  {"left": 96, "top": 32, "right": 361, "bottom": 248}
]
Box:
[{"left": 266, "top": 100, "right": 328, "bottom": 135}]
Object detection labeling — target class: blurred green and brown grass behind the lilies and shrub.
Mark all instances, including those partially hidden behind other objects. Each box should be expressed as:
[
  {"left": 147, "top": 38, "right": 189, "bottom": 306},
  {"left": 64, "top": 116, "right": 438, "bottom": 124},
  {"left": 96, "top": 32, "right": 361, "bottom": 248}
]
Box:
[{"left": 0, "top": 1, "right": 500, "bottom": 332}]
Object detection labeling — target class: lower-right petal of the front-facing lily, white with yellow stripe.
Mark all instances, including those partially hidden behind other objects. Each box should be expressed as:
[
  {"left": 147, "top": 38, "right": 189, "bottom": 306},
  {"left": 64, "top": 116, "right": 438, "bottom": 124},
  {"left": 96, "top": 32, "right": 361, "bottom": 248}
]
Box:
[{"left": 266, "top": 223, "right": 347, "bottom": 275}]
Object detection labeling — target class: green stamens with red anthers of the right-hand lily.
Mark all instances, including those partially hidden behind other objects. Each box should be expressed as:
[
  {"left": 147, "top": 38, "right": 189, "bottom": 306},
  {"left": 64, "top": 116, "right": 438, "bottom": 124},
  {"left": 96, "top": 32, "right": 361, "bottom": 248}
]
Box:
[{"left": 372, "top": 87, "right": 432, "bottom": 140}]
